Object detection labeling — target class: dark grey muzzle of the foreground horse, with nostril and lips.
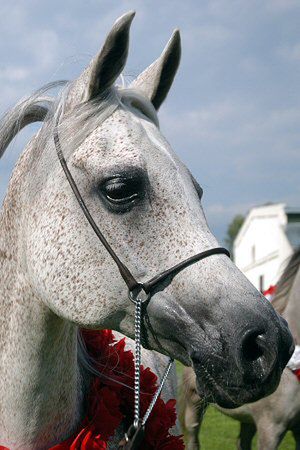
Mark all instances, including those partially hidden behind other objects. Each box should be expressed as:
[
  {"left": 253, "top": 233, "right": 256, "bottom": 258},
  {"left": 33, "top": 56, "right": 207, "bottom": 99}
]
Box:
[{"left": 190, "top": 306, "right": 294, "bottom": 408}]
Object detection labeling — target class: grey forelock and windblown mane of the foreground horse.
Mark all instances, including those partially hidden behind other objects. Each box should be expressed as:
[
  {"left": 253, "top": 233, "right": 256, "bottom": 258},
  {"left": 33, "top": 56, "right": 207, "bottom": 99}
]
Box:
[{"left": 0, "top": 80, "right": 159, "bottom": 171}]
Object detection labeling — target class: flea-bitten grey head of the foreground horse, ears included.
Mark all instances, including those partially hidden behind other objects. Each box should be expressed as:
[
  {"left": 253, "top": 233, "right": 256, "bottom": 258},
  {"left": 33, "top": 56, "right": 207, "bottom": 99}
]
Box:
[{"left": 24, "top": 13, "right": 293, "bottom": 407}]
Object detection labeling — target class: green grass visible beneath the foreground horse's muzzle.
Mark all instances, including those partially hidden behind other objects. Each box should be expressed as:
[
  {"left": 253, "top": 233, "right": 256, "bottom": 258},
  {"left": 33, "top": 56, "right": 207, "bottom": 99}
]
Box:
[{"left": 176, "top": 363, "right": 295, "bottom": 450}]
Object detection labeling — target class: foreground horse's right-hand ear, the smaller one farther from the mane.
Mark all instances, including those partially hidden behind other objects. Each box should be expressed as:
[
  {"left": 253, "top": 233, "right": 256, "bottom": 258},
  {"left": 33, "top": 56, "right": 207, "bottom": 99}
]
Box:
[{"left": 131, "top": 30, "right": 181, "bottom": 109}]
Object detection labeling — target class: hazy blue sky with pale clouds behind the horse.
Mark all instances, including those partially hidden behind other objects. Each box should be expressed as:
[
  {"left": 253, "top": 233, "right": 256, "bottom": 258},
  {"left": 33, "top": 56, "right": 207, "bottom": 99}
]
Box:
[{"left": 0, "top": 0, "right": 300, "bottom": 240}]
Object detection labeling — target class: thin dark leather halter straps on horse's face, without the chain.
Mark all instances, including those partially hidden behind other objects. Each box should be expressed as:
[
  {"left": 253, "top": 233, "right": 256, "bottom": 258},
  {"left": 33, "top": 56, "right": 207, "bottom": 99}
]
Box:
[{"left": 53, "top": 119, "right": 230, "bottom": 301}]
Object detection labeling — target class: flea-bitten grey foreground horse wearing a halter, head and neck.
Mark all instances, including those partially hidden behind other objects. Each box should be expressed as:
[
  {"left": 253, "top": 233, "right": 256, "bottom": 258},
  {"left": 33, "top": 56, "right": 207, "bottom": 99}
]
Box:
[{"left": 0, "top": 13, "right": 293, "bottom": 449}]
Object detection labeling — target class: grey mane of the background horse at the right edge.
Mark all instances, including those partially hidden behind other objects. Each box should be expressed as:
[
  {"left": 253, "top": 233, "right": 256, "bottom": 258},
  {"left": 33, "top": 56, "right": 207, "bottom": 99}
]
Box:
[{"left": 272, "top": 247, "right": 300, "bottom": 314}]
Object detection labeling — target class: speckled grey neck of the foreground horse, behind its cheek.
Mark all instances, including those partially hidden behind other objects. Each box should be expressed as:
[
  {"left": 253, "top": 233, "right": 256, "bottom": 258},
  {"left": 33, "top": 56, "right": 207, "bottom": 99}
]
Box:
[{"left": 0, "top": 143, "right": 83, "bottom": 449}]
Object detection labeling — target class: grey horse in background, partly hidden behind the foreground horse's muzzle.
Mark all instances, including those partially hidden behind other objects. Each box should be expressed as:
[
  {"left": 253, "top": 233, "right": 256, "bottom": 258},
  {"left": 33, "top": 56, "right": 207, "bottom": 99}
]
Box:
[{"left": 180, "top": 249, "right": 300, "bottom": 450}]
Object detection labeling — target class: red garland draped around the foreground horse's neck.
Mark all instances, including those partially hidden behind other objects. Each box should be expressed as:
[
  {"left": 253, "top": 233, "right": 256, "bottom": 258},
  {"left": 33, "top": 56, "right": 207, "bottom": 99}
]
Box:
[{"left": 0, "top": 330, "right": 184, "bottom": 450}]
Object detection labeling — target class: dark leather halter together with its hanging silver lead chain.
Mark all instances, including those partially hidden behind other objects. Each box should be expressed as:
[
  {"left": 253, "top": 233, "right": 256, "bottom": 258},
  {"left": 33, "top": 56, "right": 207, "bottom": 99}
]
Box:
[{"left": 53, "top": 116, "right": 230, "bottom": 450}]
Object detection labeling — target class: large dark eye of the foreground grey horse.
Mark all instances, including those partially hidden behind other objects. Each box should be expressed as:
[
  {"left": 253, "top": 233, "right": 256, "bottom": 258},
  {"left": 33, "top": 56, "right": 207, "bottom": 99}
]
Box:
[{"left": 100, "top": 177, "right": 144, "bottom": 207}]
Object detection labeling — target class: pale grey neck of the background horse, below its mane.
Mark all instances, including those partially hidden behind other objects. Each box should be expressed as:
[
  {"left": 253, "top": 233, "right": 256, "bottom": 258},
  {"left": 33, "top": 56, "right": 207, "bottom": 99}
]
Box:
[{"left": 282, "top": 268, "right": 300, "bottom": 345}]
